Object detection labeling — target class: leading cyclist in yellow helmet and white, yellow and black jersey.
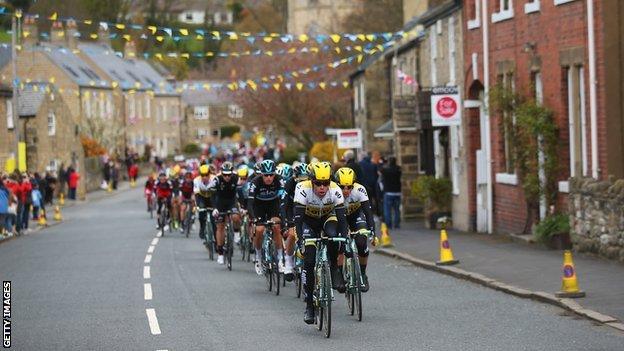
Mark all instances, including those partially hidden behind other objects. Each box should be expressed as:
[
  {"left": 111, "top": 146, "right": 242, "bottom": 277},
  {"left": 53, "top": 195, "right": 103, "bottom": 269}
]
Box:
[{"left": 294, "top": 162, "right": 348, "bottom": 324}]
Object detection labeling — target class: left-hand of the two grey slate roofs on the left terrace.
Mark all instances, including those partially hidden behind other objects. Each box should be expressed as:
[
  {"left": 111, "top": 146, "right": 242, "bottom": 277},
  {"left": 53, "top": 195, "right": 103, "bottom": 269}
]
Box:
[{"left": 33, "top": 43, "right": 111, "bottom": 88}]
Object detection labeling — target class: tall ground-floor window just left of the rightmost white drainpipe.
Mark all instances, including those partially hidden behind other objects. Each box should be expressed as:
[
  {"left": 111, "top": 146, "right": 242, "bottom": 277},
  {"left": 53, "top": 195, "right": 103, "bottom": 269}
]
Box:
[{"left": 565, "top": 66, "right": 588, "bottom": 177}]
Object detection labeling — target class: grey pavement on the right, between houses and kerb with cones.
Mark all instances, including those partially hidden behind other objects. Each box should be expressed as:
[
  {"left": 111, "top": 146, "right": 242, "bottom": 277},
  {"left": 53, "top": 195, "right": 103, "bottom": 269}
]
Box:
[{"left": 376, "top": 222, "right": 624, "bottom": 328}]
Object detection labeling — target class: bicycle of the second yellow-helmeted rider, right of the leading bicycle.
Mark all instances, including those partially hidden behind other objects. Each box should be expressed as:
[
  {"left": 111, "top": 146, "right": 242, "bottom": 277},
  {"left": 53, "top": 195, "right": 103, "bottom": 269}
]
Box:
[{"left": 343, "top": 229, "right": 371, "bottom": 322}]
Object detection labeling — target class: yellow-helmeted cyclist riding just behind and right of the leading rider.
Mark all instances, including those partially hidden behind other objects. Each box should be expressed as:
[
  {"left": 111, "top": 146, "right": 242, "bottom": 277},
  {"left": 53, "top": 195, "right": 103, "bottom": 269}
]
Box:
[{"left": 335, "top": 167, "right": 376, "bottom": 292}]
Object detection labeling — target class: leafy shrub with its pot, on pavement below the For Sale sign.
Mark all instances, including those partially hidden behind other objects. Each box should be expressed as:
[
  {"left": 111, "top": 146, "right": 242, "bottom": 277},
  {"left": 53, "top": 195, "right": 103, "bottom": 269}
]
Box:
[{"left": 412, "top": 176, "right": 453, "bottom": 228}]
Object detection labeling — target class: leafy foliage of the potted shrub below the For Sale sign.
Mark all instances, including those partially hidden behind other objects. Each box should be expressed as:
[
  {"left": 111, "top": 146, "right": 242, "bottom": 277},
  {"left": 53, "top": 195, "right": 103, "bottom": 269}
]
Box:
[{"left": 412, "top": 176, "right": 453, "bottom": 211}]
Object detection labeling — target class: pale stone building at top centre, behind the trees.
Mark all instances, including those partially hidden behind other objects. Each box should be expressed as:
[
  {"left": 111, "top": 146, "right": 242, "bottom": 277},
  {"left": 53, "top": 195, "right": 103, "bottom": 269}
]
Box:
[{"left": 288, "top": 0, "right": 362, "bottom": 34}]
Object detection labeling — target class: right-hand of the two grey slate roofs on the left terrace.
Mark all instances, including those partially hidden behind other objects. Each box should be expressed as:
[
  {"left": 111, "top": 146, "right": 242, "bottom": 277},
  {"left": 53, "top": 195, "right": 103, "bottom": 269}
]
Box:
[{"left": 78, "top": 43, "right": 175, "bottom": 94}]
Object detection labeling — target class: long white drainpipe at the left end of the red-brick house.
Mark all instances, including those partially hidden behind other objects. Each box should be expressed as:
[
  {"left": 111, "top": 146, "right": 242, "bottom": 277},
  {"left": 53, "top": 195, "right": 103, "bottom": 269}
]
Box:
[{"left": 481, "top": 0, "right": 494, "bottom": 234}]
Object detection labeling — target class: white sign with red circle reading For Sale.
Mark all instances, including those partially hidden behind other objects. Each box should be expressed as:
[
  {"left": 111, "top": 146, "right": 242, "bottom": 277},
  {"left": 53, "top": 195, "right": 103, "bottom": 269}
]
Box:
[{"left": 431, "top": 86, "right": 462, "bottom": 127}]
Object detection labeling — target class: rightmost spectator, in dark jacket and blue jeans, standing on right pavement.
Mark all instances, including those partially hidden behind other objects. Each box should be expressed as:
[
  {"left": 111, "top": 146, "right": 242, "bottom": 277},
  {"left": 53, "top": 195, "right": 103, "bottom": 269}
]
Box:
[{"left": 380, "top": 157, "right": 401, "bottom": 229}]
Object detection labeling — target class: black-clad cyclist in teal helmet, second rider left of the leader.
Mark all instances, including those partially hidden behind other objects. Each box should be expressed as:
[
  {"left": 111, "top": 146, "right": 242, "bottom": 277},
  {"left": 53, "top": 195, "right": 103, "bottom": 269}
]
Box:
[{"left": 247, "top": 160, "right": 284, "bottom": 275}]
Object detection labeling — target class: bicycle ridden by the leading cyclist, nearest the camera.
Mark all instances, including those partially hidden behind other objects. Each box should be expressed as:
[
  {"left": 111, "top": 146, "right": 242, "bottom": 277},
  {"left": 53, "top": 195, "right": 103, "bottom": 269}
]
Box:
[{"left": 304, "top": 237, "right": 345, "bottom": 338}]
